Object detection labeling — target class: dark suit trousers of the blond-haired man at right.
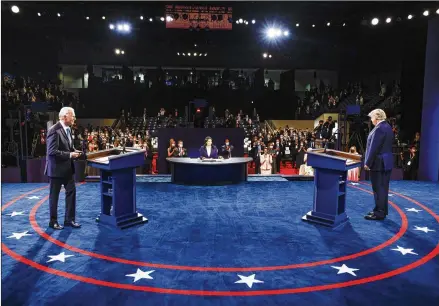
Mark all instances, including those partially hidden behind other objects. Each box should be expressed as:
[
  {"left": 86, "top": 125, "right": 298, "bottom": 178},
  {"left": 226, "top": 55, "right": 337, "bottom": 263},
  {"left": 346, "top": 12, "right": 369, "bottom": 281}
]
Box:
[{"left": 370, "top": 170, "right": 392, "bottom": 218}]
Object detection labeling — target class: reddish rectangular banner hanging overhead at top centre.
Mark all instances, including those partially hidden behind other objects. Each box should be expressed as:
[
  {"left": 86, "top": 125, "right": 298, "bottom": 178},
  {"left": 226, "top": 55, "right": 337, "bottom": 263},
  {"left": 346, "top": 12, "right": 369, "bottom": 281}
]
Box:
[{"left": 166, "top": 5, "right": 233, "bottom": 30}]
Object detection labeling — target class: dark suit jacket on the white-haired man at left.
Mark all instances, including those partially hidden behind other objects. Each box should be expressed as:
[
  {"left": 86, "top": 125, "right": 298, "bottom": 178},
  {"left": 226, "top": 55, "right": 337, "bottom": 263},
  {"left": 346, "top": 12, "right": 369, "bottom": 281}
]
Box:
[{"left": 44, "top": 122, "right": 75, "bottom": 178}]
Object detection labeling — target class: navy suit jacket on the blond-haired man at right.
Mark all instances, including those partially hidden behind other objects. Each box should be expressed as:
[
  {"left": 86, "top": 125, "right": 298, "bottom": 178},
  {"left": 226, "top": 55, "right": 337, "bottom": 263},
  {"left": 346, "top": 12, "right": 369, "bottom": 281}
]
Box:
[{"left": 364, "top": 121, "right": 394, "bottom": 171}]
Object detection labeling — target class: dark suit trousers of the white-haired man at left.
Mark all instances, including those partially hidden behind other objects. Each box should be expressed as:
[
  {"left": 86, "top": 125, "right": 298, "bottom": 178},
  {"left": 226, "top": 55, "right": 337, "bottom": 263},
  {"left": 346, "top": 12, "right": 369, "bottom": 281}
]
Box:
[{"left": 49, "top": 175, "right": 76, "bottom": 222}]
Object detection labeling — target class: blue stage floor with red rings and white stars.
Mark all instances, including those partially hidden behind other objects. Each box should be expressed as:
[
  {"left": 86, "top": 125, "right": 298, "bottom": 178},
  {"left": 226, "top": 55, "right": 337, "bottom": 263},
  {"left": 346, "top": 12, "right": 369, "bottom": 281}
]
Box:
[{"left": 1, "top": 180, "right": 439, "bottom": 306}]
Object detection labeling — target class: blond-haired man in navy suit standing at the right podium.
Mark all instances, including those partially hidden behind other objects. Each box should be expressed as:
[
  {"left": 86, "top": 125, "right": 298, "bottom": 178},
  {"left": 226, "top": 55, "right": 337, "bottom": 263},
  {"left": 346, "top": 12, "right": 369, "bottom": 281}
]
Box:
[{"left": 364, "top": 109, "right": 394, "bottom": 220}]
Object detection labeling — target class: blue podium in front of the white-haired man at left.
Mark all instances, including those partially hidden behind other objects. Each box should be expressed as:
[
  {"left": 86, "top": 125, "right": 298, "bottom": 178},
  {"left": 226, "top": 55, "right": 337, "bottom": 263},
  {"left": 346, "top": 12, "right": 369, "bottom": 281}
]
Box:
[{"left": 87, "top": 148, "right": 148, "bottom": 229}]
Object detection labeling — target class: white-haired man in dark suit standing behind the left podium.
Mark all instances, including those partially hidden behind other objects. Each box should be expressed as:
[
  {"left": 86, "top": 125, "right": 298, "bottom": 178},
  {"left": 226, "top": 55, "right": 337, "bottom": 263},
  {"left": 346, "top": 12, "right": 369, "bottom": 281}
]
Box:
[{"left": 44, "top": 107, "right": 82, "bottom": 230}]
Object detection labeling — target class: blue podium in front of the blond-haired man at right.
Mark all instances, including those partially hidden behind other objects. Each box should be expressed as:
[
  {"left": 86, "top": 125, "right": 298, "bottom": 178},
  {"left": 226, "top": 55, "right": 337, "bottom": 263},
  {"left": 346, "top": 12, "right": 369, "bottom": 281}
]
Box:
[{"left": 302, "top": 149, "right": 362, "bottom": 228}]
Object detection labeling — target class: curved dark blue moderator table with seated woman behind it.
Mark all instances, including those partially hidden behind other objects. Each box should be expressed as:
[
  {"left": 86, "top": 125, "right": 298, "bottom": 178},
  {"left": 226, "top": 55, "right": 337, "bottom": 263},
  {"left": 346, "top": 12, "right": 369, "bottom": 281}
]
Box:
[{"left": 166, "top": 157, "right": 253, "bottom": 185}]
